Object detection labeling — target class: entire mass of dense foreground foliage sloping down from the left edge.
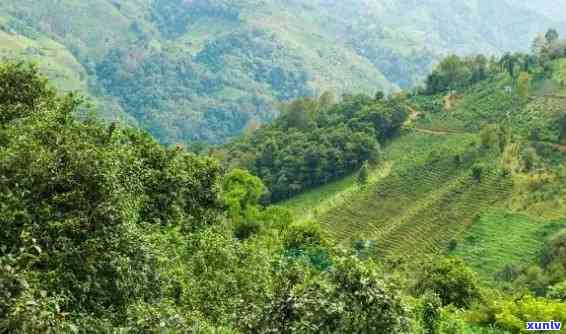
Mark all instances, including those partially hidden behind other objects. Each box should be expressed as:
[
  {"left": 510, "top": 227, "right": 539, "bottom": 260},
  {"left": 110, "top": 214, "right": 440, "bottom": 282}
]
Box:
[{"left": 0, "top": 63, "right": 422, "bottom": 333}]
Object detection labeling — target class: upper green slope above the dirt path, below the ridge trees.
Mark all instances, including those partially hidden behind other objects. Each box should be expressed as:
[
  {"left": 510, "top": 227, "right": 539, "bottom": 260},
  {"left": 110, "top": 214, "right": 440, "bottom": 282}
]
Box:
[{"left": 415, "top": 59, "right": 566, "bottom": 143}]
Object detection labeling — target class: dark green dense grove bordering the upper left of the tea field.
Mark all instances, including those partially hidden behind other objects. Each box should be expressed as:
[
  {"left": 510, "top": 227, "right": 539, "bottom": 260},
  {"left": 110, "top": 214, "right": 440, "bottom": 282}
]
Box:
[{"left": 219, "top": 93, "right": 408, "bottom": 201}]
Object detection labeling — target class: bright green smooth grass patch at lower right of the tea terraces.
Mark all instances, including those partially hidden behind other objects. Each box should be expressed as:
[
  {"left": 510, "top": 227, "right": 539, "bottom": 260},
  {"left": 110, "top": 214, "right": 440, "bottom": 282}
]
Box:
[{"left": 453, "top": 209, "right": 563, "bottom": 279}]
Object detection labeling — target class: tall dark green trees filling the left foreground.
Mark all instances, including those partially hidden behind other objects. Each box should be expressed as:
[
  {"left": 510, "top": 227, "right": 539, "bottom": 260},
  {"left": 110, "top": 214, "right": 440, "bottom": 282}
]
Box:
[{"left": 0, "top": 61, "right": 226, "bottom": 333}]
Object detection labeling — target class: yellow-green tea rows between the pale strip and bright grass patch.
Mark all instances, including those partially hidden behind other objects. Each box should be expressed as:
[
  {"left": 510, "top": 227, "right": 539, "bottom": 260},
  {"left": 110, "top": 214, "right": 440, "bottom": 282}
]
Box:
[{"left": 320, "top": 136, "right": 512, "bottom": 257}]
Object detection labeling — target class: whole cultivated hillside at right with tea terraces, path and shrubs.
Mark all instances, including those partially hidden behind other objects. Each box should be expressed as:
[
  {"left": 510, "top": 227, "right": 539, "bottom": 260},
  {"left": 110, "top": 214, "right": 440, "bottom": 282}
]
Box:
[{"left": 283, "top": 54, "right": 566, "bottom": 284}]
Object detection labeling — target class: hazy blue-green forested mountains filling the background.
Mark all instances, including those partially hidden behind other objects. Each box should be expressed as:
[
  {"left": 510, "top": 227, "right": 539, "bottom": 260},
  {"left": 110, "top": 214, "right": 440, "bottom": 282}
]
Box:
[{"left": 0, "top": 0, "right": 565, "bottom": 143}]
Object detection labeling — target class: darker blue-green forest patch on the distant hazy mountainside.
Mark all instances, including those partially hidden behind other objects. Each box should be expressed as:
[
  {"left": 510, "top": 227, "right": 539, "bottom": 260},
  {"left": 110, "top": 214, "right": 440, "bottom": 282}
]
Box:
[{"left": 95, "top": 30, "right": 311, "bottom": 143}]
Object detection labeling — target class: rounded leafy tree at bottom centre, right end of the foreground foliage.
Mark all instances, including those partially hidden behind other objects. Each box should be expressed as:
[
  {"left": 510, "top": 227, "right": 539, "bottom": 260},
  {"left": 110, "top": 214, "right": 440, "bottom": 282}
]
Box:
[{"left": 261, "top": 257, "right": 410, "bottom": 333}]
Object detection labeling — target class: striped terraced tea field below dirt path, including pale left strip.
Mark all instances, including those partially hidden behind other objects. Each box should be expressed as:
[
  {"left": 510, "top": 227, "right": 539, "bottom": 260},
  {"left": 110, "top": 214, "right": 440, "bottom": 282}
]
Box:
[{"left": 284, "top": 132, "right": 511, "bottom": 257}]
